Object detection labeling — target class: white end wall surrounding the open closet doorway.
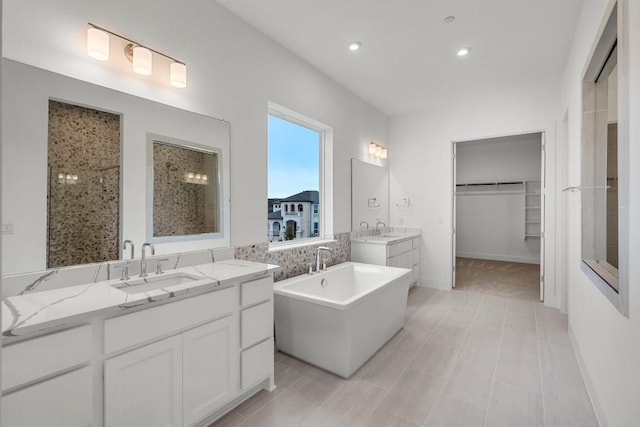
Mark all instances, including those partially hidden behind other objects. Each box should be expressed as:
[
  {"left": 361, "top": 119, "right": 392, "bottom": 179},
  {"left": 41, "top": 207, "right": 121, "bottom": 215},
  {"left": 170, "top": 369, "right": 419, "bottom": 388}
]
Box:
[{"left": 389, "top": 83, "right": 561, "bottom": 306}]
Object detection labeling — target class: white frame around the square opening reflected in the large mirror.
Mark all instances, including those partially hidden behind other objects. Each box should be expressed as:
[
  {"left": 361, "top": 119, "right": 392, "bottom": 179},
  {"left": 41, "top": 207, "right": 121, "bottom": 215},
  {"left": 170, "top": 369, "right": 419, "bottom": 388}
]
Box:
[{"left": 147, "top": 133, "right": 225, "bottom": 243}]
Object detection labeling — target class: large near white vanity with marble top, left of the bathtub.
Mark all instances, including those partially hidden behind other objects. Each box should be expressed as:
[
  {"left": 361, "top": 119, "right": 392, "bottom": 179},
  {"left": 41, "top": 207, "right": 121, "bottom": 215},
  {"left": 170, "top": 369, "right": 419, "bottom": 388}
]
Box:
[{"left": 1, "top": 260, "right": 277, "bottom": 427}]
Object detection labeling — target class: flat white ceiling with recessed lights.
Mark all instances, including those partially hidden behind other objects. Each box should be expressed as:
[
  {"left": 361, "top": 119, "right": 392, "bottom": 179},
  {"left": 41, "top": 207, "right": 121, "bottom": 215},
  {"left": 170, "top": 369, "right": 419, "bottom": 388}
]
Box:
[{"left": 218, "top": 0, "right": 583, "bottom": 115}]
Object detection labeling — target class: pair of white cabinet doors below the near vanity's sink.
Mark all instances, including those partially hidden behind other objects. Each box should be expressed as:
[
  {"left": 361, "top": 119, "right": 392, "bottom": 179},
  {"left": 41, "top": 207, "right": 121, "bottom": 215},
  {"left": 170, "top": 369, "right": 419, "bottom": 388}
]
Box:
[{"left": 105, "top": 315, "right": 238, "bottom": 427}]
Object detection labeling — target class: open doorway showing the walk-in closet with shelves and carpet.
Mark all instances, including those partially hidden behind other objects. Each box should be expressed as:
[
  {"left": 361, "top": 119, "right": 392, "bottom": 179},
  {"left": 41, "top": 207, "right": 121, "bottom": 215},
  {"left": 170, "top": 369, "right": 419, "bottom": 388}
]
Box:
[{"left": 453, "top": 132, "right": 544, "bottom": 301}]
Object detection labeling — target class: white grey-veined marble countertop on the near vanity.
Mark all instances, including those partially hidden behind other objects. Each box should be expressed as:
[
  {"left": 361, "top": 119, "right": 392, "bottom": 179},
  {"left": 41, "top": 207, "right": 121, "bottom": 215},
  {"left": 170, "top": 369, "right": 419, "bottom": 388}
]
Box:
[{"left": 2, "top": 259, "right": 279, "bottom": 340}]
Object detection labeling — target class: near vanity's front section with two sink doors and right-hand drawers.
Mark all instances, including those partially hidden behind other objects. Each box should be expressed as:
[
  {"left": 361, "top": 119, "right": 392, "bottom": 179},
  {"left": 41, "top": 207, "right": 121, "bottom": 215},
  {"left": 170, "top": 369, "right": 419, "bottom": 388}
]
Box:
[{"left": 104, "top": 276, "right": 274, "bottom": 427}]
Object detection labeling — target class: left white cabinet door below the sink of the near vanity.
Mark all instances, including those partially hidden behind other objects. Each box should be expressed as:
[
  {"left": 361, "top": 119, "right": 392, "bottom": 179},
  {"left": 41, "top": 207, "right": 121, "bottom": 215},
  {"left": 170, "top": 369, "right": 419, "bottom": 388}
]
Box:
[{"left": 104, "top": 335, "right": 182, "bottom": 427}]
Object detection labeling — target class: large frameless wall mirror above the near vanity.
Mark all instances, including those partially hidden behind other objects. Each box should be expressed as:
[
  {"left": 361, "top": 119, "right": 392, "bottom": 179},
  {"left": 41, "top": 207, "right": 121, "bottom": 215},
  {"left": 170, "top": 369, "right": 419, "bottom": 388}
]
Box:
[{"left": 1, "top": 59, "right": 231, "bottom": 275}]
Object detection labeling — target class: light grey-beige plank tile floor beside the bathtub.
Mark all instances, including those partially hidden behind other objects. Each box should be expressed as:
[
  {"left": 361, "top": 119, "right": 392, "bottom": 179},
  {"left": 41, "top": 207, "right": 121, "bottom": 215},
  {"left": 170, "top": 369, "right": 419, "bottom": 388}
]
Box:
[{"left": 212, "top": 287, "right": 598, "bottom": 427}]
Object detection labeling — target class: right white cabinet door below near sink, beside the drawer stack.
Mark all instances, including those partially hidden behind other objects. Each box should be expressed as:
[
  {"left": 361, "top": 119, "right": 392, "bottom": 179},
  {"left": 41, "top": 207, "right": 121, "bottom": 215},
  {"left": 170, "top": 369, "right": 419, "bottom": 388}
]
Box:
[{"left": 182, "top": 316, "right": 238, "bottom": 426}]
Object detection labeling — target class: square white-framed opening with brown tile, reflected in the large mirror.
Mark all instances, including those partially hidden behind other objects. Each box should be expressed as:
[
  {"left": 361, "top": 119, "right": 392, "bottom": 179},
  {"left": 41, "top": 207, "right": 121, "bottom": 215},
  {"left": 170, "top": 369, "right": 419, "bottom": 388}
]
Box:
[{"left": 147, "top": 134, "right": 222, "bottom": 242}]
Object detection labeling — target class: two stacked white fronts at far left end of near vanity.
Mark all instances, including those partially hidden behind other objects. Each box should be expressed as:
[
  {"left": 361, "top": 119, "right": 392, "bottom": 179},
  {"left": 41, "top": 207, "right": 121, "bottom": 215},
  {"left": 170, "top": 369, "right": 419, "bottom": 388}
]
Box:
[{"left": 0, "top": 325, "right": 93, "bottom": 427}]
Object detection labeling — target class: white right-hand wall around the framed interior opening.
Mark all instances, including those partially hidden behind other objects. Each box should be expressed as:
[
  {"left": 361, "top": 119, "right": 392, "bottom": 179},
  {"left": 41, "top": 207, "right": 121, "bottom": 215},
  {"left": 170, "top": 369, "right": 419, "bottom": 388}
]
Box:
[{"left": 561, "top": 0, "right": 640, "bottom": 427}]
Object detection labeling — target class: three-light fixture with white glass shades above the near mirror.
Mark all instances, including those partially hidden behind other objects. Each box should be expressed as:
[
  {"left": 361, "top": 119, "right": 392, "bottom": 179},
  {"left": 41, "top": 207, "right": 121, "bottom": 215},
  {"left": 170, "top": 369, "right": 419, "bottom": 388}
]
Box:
[{"left": 87, "top": 22, "right": 187, "bottom": 88}]
